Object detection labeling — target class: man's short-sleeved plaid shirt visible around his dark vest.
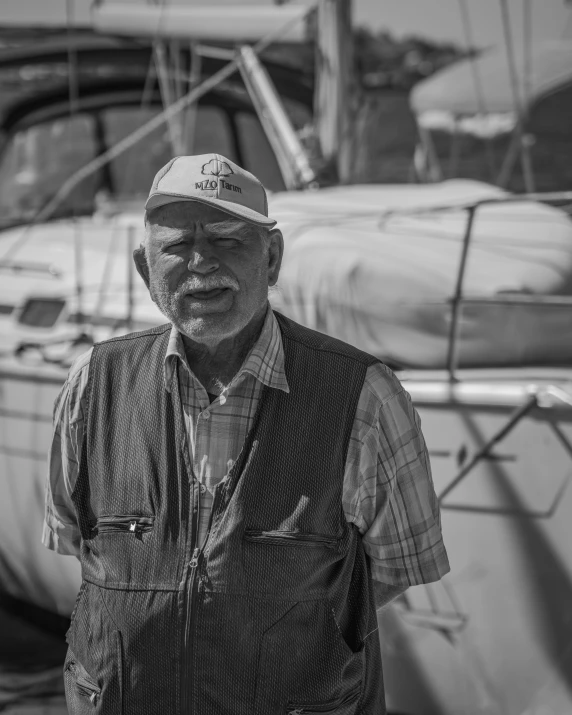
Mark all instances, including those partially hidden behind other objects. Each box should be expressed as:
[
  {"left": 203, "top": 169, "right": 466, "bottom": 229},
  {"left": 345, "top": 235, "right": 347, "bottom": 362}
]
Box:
[{"left": 43, "top": 310, "right": 449, "bottom": 587}]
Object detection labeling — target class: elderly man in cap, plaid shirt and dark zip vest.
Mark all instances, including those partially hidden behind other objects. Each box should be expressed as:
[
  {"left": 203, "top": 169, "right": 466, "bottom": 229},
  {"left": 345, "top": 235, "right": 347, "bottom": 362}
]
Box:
[{"left": 44, "top": 155, "right": 449, "bottom": 715}]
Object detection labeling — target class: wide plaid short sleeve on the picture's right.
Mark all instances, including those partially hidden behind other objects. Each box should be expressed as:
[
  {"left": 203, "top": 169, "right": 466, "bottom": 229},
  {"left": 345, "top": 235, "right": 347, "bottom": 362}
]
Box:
[{"left": 343, "top": 363, "right": 450, "bottom": 588}]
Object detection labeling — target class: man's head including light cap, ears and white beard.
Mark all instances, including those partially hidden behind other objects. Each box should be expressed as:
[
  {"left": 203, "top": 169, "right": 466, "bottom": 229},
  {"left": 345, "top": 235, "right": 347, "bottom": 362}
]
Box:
[{"left": 134, "top": 155, "right": 283, "bottom": 345}]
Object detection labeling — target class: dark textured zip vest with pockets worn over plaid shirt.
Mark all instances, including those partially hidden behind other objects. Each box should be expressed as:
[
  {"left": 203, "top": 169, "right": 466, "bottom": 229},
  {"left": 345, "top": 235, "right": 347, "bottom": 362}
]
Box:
[{"left": 64, "top": 314, "right": 385, "bottom": 715}]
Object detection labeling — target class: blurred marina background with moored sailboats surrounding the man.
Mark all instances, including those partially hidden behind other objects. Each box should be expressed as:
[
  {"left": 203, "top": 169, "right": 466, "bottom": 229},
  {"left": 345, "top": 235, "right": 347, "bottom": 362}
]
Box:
[{"left": 0, "top": 0, "right": 572, "bottom": 715}]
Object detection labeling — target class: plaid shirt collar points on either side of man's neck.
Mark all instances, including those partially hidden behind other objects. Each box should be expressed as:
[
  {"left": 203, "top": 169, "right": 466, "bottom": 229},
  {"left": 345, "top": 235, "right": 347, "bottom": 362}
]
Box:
[{"left": 164, "top": 304, "right": 290, "bottom": 392}]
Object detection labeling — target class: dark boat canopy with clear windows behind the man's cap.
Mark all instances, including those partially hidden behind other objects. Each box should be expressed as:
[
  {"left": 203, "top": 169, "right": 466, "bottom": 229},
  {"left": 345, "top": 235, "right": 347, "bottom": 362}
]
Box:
[{"left": 0, "top": 28, "right": 314, "bottom": 218}]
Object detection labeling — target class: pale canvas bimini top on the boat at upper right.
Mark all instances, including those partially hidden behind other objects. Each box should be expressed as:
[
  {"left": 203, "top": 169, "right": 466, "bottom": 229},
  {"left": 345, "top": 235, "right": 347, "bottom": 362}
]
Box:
[{"left": 410, "top": 41, "right": 572, "bottom": 136}]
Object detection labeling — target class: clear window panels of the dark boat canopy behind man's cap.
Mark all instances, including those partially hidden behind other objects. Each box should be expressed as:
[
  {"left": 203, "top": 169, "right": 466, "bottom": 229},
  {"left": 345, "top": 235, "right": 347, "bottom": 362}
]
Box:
[{"left": 0, "top": 105, "right": 284, "bottom": 228}]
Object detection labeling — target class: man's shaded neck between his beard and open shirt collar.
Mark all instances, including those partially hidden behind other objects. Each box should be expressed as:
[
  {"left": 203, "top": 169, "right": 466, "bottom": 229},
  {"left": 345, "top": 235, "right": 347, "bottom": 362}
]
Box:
[{"left": 181, "top": 310, "right": 266, "bottom": 395}]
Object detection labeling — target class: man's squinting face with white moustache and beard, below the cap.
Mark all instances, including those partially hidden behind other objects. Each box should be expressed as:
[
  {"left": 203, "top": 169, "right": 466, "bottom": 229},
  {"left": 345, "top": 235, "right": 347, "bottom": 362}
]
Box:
[{"left": 138, "top": 201, "right": 282, "bottom": 344}]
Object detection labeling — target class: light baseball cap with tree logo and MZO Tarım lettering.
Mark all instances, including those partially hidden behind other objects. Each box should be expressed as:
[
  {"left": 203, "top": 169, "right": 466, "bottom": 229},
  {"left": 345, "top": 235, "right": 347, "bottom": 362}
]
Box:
[{"left": 145, "top": 154, "right": 276, "bottom": 228}]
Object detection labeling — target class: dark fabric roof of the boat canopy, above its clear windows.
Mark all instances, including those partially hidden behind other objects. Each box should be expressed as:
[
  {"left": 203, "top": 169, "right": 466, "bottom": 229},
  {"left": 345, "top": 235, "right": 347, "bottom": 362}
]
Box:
[{"left": 0, "top": 31, "right": 313, "bottom": 134}]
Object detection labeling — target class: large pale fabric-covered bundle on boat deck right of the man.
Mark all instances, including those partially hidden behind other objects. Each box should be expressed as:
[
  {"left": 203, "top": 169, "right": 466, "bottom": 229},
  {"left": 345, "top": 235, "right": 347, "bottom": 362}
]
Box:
[{"left": 270, "top": 180, "right": 572, "bottom": 368}]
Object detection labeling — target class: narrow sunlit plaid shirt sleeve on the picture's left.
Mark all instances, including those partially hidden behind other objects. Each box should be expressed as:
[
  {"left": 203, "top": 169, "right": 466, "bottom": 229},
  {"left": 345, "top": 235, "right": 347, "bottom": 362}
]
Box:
[{"left": 42, "top": 350, "right": 92, "bottom": 556}]
